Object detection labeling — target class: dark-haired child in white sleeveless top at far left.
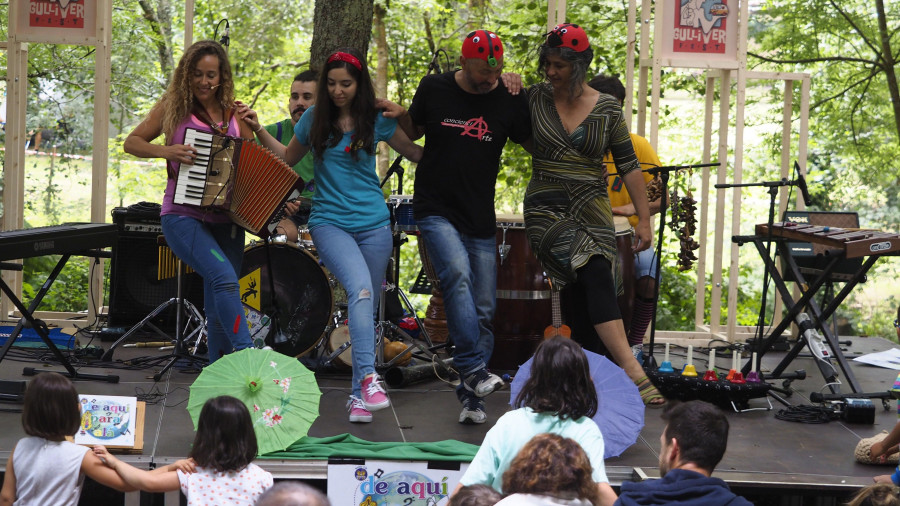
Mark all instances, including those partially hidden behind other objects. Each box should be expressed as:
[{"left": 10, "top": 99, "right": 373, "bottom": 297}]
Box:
[{"left": 0, "top": 372, "right": 183, "bottom": 506}]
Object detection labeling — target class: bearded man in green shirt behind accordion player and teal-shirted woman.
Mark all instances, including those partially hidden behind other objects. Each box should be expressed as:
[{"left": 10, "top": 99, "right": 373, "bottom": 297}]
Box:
[{"left": 256, "top": 70, "right": 319, "bottom": 242}]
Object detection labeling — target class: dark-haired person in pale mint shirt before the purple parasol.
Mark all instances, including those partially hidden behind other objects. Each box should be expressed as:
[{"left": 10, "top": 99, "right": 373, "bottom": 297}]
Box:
[{"left": 454, "top": 337, "right": 616, "bottom": 504}]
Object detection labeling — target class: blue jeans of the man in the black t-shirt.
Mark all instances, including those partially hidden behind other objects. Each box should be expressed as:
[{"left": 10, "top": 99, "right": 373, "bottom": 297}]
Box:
[{"left": 416, "top": 216, "right": 497, "bottom": 395}]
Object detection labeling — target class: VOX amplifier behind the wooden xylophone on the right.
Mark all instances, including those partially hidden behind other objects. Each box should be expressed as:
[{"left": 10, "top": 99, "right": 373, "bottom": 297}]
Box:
[{"left": 781, "top": 211, "right": 865, "bottom": 282}]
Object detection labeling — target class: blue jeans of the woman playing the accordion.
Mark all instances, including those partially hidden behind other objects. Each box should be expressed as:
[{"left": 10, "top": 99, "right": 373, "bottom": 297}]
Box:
[{"left": 161, "top": 214, "right": 253, "bottom": 363}]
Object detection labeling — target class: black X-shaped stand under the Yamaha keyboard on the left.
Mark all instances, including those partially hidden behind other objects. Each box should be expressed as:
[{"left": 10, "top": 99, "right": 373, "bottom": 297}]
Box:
[{"left": 0, "top": 250, "right": 119, "bottom": 383}]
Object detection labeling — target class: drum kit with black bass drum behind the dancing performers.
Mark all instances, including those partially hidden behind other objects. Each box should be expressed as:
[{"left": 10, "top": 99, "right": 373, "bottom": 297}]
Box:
[{"left": 240, "top": 195, "right": 450, "bottom": 384}]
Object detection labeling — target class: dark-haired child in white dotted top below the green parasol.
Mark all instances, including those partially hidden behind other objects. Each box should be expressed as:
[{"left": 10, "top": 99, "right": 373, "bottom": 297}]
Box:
[{"left": 94, "top": 395, "right": 273, "bottom": 505}]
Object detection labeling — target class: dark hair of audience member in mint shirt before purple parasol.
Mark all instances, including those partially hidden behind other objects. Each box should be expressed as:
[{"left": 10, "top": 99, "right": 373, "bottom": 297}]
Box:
[{"left": 516, "top": 337, "right": 598, "bottom": 420}]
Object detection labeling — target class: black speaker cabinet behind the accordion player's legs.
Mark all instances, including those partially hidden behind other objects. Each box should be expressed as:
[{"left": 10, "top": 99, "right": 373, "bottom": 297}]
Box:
[{"left": 107, "top": 202, "right": 203, "bottom": 332}]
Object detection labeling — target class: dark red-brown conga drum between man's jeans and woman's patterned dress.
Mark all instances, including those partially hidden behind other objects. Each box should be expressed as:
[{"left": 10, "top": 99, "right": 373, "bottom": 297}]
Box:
[{"left": 488, "top": 214, "right": 553, "bottom": 370}]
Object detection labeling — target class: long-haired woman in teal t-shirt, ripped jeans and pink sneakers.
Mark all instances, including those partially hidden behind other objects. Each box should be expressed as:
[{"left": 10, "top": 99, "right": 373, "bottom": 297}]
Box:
[{"left": 238, "top": 49, "right": 422, "bottom": 422}]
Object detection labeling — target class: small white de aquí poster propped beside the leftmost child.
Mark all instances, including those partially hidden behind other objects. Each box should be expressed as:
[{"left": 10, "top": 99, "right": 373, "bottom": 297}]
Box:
[{"left": 75, "top": 394, "right": 137, "bottom": 447}]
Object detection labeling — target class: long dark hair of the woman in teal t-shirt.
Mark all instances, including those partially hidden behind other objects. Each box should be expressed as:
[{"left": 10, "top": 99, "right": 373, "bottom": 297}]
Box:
[{"left": 309, "top": 48, "right": 375, "bottom": 160}]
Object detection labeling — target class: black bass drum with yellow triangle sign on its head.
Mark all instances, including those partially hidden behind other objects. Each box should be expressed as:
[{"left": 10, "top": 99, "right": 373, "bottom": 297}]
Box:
[{"left": 241, "top": 242, "right": 333, "bottom": 356}]
